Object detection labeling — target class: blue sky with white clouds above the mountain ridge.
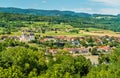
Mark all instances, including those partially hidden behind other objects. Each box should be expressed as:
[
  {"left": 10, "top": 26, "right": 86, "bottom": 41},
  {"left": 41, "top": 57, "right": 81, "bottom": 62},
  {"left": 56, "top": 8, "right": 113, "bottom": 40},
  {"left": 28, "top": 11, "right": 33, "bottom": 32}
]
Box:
[{"left": 0, "top": 0, "right": 120, "bottom": 15}]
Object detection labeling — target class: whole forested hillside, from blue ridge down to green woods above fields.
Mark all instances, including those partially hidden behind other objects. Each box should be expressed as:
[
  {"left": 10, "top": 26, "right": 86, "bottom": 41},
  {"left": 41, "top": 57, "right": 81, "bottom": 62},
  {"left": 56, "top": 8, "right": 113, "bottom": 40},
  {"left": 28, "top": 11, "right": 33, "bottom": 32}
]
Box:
[{"left": 0, "top": 8, "right": 120, "bottom": 32}]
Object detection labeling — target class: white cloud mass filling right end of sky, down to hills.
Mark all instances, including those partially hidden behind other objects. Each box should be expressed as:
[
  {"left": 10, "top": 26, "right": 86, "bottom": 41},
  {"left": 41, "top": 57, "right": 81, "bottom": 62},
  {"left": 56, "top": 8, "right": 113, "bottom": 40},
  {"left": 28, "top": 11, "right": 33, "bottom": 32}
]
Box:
[{"left": 90, "top": 0, "right": 120, "bottom": 15}]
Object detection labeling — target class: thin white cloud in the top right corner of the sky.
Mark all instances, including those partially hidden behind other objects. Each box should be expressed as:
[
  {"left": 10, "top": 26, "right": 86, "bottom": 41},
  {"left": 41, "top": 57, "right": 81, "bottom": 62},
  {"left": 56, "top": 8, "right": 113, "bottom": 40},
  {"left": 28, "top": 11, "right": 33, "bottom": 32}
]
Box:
[{"left": 91, "top": 0, "right": 120, "bottom": 6}]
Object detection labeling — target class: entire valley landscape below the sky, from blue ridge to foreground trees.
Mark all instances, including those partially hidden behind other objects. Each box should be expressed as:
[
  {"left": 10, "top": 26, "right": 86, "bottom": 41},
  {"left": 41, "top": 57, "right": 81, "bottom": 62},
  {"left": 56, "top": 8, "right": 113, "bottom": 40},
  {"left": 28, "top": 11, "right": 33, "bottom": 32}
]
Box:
[{"left": 0, "top": 8, "right": 120, "bottom": 78}]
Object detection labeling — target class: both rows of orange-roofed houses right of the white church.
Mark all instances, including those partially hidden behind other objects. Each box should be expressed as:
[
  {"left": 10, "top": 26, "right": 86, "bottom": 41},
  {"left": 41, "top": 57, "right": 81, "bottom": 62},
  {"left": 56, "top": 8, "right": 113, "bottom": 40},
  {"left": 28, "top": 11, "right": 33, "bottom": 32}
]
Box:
[{"left": 40, "top": 36, "right": 120, "bottom": 55}]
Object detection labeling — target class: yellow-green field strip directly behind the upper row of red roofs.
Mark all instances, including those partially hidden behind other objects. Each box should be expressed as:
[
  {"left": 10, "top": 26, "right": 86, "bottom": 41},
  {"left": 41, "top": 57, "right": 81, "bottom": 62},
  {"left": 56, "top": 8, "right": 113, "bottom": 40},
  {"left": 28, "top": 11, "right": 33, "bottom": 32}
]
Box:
[{"left": 44, "top": 28, "right": 120, "bottom": 37}]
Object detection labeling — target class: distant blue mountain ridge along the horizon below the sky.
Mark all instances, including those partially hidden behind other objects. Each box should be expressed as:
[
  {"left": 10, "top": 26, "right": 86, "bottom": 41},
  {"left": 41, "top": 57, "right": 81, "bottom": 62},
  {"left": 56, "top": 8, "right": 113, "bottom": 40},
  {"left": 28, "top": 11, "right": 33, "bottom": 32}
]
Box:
[{"left": 0, "top": 7, "right": 120, "bottom": 17}]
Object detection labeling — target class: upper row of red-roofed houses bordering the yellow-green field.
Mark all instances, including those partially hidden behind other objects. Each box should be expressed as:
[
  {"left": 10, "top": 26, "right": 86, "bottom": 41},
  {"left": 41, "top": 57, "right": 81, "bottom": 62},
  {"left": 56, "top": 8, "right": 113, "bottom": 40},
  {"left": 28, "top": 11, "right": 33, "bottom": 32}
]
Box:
[{"left": 40, "top": 36, "right": 120, "bottom": 44}]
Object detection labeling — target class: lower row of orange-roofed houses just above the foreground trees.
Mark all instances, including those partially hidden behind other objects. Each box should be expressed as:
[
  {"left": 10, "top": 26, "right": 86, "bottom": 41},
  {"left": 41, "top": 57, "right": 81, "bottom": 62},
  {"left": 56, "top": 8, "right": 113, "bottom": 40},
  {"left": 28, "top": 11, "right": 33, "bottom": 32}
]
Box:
[{"left": 48, "top": 46, "right": 112, "bottom": 55}]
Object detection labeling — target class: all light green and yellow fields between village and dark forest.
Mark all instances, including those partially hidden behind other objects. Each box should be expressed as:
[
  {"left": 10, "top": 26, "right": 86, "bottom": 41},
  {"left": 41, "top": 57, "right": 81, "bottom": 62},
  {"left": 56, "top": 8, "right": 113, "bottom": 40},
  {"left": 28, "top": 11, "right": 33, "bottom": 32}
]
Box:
[{"left": 0, "top": 22, "right": 120, "bottom": 37}]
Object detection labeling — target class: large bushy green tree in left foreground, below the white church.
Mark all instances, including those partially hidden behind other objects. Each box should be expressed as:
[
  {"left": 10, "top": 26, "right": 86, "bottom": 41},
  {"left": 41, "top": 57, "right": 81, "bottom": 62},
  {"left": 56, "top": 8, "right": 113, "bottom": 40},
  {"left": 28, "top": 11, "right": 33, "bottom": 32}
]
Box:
[{"left": 0, "top": 47, "right": 47, "bottom": 76}]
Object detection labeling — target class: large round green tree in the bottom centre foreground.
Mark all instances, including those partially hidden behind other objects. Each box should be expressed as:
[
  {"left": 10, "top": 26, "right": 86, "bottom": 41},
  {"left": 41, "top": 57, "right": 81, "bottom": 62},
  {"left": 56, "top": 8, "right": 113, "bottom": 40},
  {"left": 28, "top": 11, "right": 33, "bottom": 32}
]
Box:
[{"left": 44, "top": 52, "right": 91, "bottom": 78}]
